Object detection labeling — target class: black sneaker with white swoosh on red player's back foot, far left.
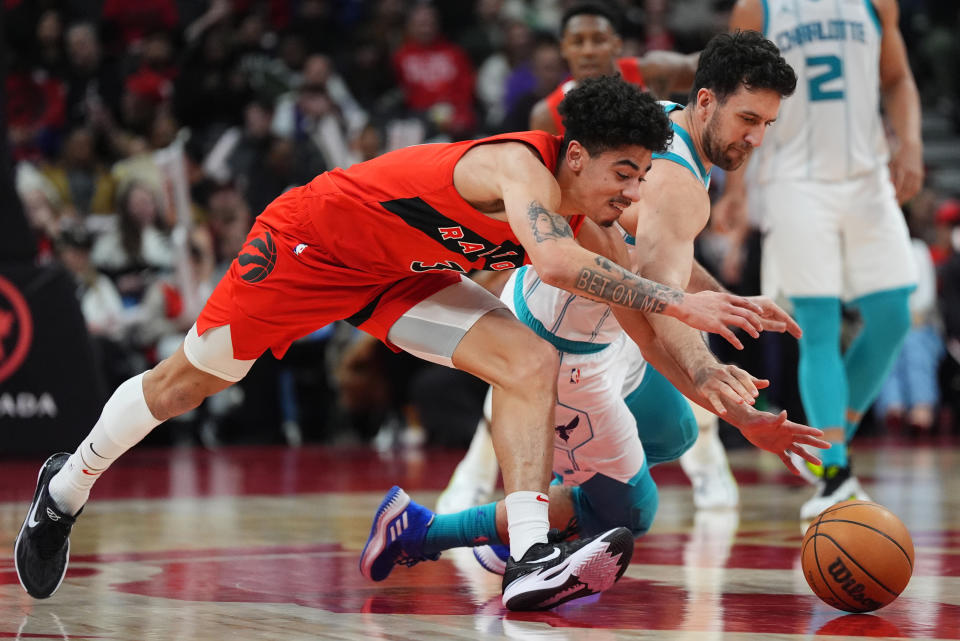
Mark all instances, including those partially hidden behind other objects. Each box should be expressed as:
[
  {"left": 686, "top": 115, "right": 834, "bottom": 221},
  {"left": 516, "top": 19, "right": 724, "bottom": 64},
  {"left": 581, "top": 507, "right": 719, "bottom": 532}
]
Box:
[{"left": 14, "top": 452, "right": 83, "bottom": 599}]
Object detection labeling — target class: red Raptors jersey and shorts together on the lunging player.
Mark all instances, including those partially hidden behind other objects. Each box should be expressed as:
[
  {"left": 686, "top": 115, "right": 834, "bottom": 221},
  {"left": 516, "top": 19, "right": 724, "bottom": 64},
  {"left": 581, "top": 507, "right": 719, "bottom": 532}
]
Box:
[{"left": 197, "top": 131, "right": 583, "bottom": 360}]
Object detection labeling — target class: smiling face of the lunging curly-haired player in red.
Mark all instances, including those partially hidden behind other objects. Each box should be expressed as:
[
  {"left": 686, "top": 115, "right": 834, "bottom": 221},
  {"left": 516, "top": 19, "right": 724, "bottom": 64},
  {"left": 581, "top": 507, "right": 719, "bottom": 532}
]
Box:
[{"left": 580, "top": 146, "right": 652, "bottom": 227}]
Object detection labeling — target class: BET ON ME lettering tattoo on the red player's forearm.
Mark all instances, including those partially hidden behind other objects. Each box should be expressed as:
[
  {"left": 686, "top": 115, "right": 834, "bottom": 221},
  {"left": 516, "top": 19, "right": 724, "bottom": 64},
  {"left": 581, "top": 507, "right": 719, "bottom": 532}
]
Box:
[{"left": 573, "top": 257, "right": 683, "bottom": 314}]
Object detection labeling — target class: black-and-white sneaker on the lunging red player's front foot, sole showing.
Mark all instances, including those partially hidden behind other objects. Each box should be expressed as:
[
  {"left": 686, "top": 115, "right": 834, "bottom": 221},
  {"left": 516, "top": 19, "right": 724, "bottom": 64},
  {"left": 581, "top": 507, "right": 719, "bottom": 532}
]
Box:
[{"left": 503, "top": 527, "right": 633, "bottom": 610}]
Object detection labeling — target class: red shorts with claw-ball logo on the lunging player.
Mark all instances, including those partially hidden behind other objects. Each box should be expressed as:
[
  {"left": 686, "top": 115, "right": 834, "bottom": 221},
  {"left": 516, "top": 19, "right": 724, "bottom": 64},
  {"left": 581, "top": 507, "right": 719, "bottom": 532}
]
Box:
[{"left": 197, "top": 194, "right": 460, "bottom": 360}]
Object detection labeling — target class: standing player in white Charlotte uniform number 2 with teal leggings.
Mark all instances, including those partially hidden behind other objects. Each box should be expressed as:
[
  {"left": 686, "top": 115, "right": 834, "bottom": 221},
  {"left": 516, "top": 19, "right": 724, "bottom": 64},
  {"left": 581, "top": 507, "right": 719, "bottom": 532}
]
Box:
[{"left": 728, "top": 0, "right": 923, "bottom": 519}]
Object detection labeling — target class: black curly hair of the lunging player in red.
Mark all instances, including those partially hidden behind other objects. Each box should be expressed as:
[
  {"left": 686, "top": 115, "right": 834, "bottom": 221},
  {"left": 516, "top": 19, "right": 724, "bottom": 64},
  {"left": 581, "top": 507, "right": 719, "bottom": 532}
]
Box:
[{"left": 559, "top": 75, "right": 673, "bottom": 154}]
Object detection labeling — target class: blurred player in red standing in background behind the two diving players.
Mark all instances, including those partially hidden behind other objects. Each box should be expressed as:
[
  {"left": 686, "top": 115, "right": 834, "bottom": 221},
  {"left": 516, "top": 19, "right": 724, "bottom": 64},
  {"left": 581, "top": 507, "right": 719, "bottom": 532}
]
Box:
[{"left": 530, "top": 2, "right": 700, "bottom": 135}]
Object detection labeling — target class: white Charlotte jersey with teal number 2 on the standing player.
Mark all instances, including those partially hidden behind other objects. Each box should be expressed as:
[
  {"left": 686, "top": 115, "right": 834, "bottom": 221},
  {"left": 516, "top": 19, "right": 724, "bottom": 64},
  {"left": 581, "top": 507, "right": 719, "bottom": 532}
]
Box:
[{"left": 750, "top": 0, "right": 888, "bottom": 183}]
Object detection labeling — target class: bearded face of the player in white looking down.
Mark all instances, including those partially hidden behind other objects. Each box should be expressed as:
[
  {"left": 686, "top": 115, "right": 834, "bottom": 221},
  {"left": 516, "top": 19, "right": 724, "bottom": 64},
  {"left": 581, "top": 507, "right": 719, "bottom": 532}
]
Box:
[{"left": 703, "top": 86, "right": 780, "bottom": 171}]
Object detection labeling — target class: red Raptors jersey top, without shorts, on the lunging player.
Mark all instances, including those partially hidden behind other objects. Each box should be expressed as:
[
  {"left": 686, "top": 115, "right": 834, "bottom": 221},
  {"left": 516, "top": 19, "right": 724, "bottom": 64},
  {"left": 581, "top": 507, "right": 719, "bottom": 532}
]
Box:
[{"left": 259, "top": 131, "right": 582, "bottom": 282}]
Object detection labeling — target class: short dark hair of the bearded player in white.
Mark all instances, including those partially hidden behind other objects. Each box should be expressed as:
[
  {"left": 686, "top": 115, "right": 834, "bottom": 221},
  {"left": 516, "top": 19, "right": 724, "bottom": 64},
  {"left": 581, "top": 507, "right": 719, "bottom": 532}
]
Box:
[{"left": 690, "top": 31, "right": 797, "bottom": 104}]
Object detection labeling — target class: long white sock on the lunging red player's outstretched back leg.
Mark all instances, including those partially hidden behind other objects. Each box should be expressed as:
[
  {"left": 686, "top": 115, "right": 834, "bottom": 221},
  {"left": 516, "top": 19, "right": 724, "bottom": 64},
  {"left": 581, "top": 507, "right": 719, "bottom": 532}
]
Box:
[{"left": 50, "top": 374, "right": 160, "bottom": 514}]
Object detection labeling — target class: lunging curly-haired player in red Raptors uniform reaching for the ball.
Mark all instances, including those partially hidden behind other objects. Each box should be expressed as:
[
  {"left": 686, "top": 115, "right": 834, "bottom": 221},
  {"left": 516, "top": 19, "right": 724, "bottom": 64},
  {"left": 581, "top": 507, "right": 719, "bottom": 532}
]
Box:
[{"left": 15, "top": 77, "right": 808, "bottom": 608}]
